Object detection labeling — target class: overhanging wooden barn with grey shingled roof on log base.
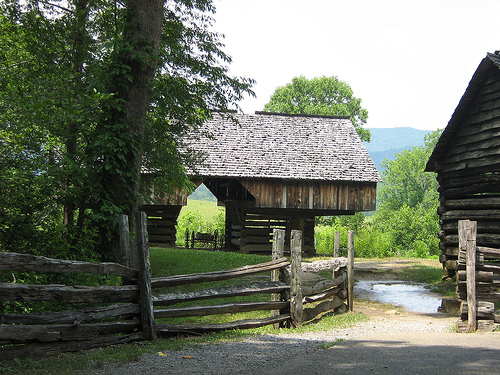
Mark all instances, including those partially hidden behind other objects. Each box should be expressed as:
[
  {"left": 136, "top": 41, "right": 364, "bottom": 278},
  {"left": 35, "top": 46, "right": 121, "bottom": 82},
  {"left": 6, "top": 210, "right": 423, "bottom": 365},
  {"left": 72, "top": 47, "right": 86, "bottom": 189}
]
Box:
[{"left": 143, "top": 112, "right": 380, "bottom": 254}]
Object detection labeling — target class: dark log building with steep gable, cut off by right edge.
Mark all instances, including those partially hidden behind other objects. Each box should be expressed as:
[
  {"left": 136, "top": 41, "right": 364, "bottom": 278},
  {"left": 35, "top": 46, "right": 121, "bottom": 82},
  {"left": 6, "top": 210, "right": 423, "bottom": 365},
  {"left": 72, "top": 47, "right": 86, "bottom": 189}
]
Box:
[{"left": 426, "top": 52, "right": 500, "bottom": 278}]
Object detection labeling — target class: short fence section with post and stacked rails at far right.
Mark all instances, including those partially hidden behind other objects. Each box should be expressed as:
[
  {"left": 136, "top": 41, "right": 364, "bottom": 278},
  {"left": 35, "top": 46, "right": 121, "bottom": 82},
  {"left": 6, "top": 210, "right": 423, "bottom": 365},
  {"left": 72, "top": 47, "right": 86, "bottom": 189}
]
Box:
[{"left": 457, "top": 220, "right": 500, "bottom": 332}]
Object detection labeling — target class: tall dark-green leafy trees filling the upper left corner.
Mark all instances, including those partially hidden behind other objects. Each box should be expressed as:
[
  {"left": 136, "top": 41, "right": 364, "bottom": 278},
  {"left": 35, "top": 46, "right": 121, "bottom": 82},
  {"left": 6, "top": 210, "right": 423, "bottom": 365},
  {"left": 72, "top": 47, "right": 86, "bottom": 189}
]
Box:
[{"left": 0, "top": 0, "right": 253, "bottom": 258}]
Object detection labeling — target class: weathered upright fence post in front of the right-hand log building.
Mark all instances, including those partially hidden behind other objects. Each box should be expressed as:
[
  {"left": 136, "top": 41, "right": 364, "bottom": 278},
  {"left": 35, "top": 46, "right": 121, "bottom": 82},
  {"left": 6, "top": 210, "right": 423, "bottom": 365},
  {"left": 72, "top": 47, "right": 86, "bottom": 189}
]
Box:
[{"left": 458, "top": 220, "right": 477, "bottom": 332}]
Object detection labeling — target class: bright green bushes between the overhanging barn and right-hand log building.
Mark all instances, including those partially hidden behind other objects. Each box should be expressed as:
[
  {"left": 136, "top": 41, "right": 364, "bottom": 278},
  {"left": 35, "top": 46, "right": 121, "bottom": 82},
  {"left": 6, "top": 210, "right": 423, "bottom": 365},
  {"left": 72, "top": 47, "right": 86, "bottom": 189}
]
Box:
[{"left": 316, "top": 130, "right": 440, "bottom": 257}]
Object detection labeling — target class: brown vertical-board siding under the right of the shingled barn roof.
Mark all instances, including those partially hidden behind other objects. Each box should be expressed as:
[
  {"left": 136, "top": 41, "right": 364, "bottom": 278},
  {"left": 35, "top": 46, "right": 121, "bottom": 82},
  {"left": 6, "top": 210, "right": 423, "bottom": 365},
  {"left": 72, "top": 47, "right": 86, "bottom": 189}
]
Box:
[{"left": 239, "top": 179, "right": 376, "bottom": 211}]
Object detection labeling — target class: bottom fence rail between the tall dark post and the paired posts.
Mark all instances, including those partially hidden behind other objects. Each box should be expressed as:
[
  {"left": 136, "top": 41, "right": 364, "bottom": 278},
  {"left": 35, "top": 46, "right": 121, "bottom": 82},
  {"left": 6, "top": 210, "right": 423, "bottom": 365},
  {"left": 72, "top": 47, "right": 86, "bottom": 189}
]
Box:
[{"left": 157, "top": 314, "right": 290, "bottom": 337}]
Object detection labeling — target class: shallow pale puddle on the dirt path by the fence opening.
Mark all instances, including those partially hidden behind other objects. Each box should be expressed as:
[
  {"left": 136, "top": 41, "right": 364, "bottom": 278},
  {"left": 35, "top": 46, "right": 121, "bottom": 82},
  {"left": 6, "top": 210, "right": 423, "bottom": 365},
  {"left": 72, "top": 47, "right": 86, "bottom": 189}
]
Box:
[{"left": 354, "top": 280, "right": 441, "bottom": 313}]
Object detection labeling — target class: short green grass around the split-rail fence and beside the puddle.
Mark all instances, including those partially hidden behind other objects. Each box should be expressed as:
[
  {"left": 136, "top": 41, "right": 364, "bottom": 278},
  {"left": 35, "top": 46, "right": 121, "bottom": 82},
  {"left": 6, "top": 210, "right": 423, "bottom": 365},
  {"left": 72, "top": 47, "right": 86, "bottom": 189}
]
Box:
[{"left": 0, "top": 248, "right": 454, "bottom": 375}]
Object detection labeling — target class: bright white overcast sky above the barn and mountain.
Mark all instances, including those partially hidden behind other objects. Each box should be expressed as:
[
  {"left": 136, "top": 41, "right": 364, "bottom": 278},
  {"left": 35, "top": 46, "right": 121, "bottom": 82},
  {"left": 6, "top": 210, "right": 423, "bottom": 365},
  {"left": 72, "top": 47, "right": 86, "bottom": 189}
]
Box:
[{"left": 214, "top": 0, "right": 500, "bottom": 130}]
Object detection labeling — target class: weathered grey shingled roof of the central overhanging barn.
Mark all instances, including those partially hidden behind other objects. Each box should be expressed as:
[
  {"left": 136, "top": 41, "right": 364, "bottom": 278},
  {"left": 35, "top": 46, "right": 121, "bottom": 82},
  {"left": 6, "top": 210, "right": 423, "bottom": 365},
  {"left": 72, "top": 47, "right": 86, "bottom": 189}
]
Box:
[{"left": 187, "top": 112, "right": 381, "bottom": 182}]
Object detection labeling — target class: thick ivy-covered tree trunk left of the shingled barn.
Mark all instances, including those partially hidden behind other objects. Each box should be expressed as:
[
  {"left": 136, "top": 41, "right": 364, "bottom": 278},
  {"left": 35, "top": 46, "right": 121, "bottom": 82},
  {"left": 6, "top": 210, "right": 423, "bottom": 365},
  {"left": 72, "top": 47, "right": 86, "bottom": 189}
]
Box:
[{"left": 101, "top": 0, "right": 164, "bottom": 260}]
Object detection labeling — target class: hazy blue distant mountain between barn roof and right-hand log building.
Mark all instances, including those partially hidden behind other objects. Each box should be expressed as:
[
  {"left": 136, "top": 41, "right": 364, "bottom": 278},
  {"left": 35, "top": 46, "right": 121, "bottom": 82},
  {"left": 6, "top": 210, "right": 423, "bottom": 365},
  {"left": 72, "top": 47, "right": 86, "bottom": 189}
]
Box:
[{"left": 364, "top": 127, "right": 429, "bottom": 172}]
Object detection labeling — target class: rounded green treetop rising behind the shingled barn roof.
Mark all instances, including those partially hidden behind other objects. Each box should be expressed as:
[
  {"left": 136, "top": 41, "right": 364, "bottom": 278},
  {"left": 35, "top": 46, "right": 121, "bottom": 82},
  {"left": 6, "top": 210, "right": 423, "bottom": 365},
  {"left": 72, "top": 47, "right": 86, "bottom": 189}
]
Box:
[{"left": 264, "top": 76, "right": 370, "bottom": 142}]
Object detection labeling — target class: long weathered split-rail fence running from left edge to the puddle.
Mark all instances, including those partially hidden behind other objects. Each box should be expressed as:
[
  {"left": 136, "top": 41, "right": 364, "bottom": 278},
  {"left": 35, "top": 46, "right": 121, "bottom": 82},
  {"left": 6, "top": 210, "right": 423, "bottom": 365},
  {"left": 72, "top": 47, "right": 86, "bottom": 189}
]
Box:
[{"left": 0, "top": 213, "right": 354, "bottom": 360}]
